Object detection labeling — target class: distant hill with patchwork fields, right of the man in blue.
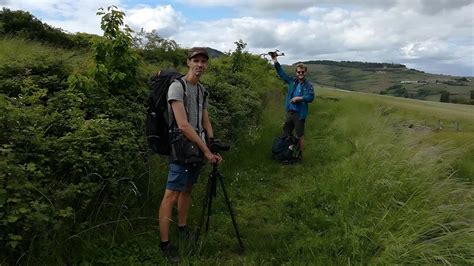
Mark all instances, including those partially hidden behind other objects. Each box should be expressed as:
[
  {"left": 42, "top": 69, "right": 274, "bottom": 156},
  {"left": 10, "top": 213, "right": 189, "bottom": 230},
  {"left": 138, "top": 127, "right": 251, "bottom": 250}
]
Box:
[{"left": 284, "top": 60, "right": 474, "bottom": 104}]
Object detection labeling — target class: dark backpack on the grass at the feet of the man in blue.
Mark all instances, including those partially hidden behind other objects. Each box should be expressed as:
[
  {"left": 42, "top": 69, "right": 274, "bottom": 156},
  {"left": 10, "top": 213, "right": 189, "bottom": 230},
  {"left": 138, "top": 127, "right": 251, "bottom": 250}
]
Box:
[{"left": 272, "top": 135, "right": 301, "bottom": 163}]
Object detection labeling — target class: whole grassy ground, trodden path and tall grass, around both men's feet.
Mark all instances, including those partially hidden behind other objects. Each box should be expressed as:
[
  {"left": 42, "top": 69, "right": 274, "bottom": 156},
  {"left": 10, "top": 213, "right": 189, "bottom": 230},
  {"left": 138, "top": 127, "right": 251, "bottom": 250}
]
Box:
[{"left": 90, "top": 88, "right": 474, "bottom": 265}]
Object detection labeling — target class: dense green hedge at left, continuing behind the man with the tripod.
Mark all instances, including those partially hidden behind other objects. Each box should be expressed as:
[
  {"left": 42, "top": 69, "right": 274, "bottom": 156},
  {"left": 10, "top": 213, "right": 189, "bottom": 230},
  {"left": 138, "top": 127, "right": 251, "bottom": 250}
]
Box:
[{"left": 0, "top": 8, "right": 280, "bottom": 264}]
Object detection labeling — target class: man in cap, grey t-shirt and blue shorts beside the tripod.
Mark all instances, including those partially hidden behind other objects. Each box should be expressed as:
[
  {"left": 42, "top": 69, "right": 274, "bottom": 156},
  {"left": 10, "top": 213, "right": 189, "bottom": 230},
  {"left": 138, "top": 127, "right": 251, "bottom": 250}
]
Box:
[{"left": 159, "top": 47, "right": 222, "bottom": 263}]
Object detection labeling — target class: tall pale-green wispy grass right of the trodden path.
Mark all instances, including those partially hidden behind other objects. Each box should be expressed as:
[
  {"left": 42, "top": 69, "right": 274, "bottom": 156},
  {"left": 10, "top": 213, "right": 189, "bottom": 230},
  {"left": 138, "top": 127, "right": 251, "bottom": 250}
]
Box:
[{"left": 294, "top": 92, "right": 474, "bottom": 264}]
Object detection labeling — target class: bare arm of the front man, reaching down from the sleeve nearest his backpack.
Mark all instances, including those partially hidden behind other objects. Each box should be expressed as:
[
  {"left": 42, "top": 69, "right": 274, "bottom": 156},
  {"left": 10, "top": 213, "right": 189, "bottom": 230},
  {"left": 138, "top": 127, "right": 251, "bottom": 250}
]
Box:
[{"left": 170, "top": 101, "right": 222, "bottom": 163}]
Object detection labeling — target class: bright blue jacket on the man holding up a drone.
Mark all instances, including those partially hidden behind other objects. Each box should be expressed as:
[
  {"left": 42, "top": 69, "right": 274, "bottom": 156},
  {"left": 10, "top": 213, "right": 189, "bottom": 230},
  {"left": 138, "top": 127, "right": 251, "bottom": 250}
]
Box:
[{"left": 275, "top": 62, "right": 314, "bottom": 119}]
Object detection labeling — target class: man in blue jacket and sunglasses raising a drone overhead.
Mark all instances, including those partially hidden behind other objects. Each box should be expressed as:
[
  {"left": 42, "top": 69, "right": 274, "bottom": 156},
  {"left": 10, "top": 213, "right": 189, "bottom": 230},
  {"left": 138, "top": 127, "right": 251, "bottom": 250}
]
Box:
[{"left": 272, "top": 54, "right": 314, "bottom": 157}]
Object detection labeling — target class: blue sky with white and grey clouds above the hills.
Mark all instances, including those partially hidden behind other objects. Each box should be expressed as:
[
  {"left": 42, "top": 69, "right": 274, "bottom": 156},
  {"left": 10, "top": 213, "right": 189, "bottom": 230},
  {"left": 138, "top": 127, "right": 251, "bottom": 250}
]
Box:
[{"left": 0, "top": 0, "right": 474, "bottom": 76}]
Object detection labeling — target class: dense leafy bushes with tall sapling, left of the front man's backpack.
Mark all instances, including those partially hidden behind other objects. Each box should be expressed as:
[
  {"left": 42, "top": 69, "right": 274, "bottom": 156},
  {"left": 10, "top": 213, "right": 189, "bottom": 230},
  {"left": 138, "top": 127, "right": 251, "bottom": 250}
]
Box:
[{"left": 0, "top": 6, "right": 145, "bottom": 264}]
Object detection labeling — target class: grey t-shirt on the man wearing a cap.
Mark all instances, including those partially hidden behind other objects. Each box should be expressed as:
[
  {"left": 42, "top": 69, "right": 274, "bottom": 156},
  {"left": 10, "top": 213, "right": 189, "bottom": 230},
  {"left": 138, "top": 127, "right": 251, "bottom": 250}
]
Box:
[{"left": 168, "top": 78, "right": 207, "bottom": 132}]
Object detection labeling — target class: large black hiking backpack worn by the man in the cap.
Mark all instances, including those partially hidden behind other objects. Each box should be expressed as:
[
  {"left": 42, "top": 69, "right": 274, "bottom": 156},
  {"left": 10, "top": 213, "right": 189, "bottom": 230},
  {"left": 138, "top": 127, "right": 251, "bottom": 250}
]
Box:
[{"left": 145, "top": 69, "right": 185, "bottom": 155}]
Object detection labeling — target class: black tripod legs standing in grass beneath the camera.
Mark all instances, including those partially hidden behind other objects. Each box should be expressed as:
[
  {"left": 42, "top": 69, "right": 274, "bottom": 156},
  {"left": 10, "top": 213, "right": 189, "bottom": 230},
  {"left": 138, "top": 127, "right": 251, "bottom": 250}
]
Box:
[{"left": 196, "top": 163, "right": 244, "bottom": 251}]
